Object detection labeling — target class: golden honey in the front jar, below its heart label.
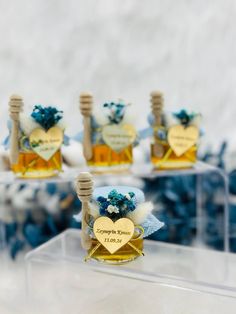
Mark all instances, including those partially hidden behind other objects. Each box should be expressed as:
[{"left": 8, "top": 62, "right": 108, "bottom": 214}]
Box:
[{"left": 88, "top": 238, "right": 143, "bottom": 264}]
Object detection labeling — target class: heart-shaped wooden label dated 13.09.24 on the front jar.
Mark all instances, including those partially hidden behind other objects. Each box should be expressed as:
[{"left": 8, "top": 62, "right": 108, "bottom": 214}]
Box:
[{"left": 93, "top": 217, "right": 134, "bottom": 254}]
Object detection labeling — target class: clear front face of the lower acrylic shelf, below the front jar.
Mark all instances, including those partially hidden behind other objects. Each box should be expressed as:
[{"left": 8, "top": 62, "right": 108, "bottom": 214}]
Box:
[{"left": 24, "top": 262, "right": 236, "bottom": 314}]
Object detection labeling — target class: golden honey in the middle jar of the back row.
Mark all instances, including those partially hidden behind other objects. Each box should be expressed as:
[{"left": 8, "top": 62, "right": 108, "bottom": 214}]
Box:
[{"left": 88, "top": 144, "right": 133, "bottom": 171}]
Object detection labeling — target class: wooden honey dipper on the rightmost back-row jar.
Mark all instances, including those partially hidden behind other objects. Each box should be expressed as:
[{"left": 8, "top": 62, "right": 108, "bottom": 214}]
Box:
[{"left": 151, "top": 91, "right": 164, "bottom": 158}]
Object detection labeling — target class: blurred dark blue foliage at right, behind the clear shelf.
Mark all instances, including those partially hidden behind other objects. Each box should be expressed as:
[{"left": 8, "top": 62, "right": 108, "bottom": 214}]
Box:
[{"left": 144, "top": 143, "right": 228, "bottom": 251}]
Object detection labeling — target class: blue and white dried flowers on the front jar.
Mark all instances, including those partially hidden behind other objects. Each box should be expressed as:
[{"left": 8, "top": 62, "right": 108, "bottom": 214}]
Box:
[{"left": 97, "top": 190, "right": 136, "bottom": 219}]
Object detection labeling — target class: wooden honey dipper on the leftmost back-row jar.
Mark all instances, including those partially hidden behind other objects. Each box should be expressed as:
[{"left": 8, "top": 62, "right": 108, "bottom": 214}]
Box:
[{"left": 9, "top": 95, "right": 23, "bottom": 165}]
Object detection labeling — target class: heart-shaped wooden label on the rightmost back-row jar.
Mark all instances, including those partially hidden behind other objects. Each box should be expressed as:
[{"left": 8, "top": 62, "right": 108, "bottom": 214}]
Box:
[{"left": 167, "top": 125, "right": 199, "bottom": 157}]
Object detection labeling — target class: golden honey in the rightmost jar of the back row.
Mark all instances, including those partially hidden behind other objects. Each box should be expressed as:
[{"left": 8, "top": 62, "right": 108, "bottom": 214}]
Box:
[{"left": 151, "top": 142, "right": 197, "bottom": 170}]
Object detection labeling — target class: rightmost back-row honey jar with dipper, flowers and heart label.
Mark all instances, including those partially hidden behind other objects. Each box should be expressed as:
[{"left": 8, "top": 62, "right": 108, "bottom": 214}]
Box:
[{"left": 149, "top": 92, "right": 201, "bottom": 170}]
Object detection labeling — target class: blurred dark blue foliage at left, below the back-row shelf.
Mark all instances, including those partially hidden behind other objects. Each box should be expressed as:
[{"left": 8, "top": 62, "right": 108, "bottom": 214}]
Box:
[{"left": 4, "top": 183, "right": 81, "bottom": 259}]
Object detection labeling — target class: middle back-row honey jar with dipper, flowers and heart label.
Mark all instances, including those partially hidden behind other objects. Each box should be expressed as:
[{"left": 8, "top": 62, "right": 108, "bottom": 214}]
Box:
[{"left": 80, "top": 93, "right": 137, "bottom": 172}]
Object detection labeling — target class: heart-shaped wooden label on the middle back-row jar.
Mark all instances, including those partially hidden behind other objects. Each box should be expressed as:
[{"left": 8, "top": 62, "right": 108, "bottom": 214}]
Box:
[{"left": 102, "top": 124, "right": 136, "bottom": 153}]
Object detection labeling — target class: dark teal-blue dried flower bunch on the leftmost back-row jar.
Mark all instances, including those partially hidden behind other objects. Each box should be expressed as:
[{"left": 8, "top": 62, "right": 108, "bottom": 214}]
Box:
[{"left": 31, "top": 105, "right": 63, "bottom": 130}]
